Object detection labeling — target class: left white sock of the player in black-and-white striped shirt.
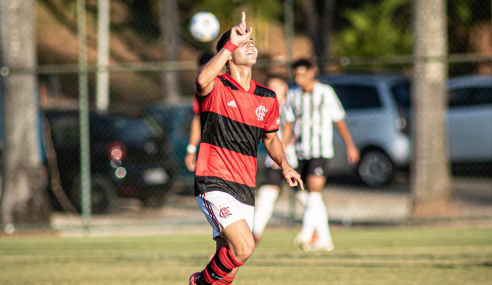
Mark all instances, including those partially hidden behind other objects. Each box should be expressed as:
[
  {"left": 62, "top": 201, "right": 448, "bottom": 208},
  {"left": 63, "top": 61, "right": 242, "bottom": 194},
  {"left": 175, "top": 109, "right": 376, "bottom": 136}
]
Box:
[{"left": 299, "top": 192, "right": 326, "bottom": 242}]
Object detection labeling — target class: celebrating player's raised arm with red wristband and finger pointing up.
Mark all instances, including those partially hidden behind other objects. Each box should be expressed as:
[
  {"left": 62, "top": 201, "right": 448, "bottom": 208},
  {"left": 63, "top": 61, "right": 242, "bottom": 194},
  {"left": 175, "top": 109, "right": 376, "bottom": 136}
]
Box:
[{"left": 195, "top": 12, "right": 253, "bottom": 96}]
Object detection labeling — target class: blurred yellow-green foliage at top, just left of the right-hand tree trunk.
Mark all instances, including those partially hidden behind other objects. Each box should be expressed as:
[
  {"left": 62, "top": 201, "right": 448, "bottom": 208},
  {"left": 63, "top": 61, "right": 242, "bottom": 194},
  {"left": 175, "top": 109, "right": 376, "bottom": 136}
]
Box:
[{"left": 333, "top": 0, "right": 412, "bottom": 56}]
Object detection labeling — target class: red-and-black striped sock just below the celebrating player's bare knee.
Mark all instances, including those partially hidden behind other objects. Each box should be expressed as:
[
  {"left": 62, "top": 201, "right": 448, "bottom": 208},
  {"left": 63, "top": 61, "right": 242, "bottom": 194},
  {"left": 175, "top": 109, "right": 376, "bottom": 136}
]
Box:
[{"left": 201, "top": 247, "right": 244, "bottom": 284}]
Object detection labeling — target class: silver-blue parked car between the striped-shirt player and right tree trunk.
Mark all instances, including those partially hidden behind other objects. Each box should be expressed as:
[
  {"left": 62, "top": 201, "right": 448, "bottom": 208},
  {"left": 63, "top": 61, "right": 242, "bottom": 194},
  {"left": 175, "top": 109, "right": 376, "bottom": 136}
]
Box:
[{"left": 319, "top": 75, "right": 411, "bottom": 187}]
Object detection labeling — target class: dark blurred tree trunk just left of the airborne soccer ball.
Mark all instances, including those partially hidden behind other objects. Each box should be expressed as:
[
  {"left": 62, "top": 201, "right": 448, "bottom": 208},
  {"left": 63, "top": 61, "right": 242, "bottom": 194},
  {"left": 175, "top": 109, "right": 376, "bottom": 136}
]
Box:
[{"left": 159, "top": 0, "right": 181, "bottom": 104}]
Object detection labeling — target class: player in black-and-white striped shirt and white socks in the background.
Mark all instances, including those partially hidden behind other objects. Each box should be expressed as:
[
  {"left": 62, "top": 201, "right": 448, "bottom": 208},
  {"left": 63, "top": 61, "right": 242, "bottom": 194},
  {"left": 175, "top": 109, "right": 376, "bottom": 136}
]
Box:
[{"left": 282, "top": 59, "right": 359, "bottom": 251}]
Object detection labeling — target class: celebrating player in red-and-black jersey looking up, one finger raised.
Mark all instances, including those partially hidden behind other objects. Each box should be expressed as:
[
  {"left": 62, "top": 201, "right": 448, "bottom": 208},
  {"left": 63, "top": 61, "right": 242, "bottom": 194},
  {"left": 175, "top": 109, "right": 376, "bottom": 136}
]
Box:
[{"left": 189, "top": 12, "right": 304, "bottom": 285}]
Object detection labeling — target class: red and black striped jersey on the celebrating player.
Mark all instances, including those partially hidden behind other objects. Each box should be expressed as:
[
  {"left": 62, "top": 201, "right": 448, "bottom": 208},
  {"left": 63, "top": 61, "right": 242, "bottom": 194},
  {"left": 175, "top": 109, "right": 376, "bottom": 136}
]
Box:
[{"left": 195, "top": 73, "right": 280, "bottom": 206}]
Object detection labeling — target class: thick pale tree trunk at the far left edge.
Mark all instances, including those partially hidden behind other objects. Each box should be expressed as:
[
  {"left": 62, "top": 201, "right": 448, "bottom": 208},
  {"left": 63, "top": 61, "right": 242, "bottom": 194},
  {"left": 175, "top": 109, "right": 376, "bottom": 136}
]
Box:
[{"left": 0, "top": 0, "right": 49, "bottom": 224}]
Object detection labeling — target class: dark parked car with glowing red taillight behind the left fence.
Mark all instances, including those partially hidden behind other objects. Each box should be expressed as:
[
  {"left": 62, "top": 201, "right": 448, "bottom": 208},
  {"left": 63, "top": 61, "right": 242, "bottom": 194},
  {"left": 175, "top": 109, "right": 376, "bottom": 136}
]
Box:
[{"left": 43, "top": 110, "right": 174, "bottom": 213}]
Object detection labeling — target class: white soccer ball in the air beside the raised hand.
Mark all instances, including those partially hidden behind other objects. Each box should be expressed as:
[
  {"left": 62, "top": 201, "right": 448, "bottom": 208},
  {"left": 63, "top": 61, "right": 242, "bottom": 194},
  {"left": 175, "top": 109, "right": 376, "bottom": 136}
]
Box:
[{"left": 189, "top": 12, "right": 220, "bottom": 42}]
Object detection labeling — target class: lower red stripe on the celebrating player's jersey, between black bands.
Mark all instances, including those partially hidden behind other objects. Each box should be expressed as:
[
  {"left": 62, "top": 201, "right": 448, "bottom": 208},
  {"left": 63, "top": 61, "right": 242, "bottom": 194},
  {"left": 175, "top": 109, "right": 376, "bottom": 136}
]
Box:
[{"left": 195, "top": 143, "right": 256, "bottom": 187}]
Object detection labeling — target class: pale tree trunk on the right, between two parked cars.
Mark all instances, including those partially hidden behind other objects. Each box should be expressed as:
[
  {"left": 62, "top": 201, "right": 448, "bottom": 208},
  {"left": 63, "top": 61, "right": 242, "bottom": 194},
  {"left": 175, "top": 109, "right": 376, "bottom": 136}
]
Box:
[{"left": 411, "top": 0, "right": 455, "bottom": 217}]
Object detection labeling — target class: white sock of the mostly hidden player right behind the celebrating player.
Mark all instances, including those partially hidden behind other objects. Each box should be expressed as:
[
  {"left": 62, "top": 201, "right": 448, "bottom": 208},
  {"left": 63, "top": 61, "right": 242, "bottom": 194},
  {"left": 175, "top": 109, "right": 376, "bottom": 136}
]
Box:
[{"left": 253, "top": 185, "right": 280, "bottom": 237}]
